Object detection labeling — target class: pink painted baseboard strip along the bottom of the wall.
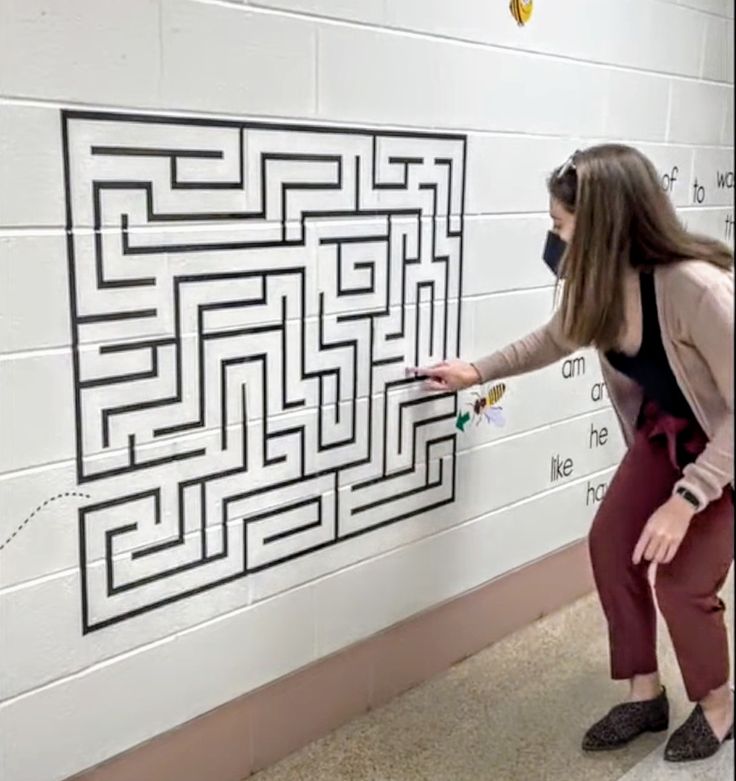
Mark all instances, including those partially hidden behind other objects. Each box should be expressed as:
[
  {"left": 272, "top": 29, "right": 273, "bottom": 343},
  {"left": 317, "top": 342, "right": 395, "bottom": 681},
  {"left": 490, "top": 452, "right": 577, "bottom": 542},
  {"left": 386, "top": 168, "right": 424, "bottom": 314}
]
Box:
[{"left": 69, "top": 542, "right": 593, "bottom": 781}]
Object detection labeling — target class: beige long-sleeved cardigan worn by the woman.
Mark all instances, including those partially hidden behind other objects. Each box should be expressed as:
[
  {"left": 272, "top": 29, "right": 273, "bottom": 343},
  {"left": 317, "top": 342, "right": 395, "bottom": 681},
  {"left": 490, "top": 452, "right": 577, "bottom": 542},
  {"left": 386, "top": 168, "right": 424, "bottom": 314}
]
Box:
[{"left": 473, "top": 260, "right": 734, "bottom": 505}]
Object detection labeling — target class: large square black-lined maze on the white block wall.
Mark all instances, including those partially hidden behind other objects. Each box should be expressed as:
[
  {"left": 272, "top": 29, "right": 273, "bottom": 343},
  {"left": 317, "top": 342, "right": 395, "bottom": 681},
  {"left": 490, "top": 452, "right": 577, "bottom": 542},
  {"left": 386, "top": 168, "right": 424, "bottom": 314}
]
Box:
[{"left": 62, "top": 111, "right": 467, "bottom": 633}]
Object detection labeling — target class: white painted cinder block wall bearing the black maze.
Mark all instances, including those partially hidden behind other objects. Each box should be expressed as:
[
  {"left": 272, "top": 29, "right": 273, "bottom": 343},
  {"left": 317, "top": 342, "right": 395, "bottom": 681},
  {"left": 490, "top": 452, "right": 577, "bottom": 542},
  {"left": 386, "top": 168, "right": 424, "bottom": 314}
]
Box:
[{"left": 0, "top": 0, "right": 734, "bottom": 781}]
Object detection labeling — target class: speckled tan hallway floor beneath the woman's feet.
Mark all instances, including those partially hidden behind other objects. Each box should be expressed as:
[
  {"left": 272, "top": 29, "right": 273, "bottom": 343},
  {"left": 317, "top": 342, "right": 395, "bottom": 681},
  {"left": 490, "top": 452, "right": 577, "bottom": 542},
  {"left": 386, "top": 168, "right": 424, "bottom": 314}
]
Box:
[{"left": 251, "top": 573, "right": 734, "bottom": 781}]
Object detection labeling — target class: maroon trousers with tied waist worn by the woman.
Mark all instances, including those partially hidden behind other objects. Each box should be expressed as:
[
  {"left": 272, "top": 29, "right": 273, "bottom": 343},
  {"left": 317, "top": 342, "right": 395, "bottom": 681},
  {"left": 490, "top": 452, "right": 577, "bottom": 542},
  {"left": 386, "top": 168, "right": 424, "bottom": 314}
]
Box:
[{"left": 589, "top": 405, "right": 734, "bottom": 702}]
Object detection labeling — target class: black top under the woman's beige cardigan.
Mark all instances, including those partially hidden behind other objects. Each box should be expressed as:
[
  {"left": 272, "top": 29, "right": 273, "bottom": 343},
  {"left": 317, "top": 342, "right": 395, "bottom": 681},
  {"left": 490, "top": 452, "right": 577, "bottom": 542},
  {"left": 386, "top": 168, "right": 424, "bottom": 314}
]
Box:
[{"left": 606, "top": 272, "right": 693, "bottom": 420}]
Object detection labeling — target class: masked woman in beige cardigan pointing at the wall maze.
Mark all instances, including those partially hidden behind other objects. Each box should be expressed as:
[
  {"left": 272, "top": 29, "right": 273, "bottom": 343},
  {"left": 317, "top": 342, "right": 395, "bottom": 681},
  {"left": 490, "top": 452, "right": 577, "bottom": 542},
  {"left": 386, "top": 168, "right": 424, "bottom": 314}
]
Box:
[{"left": 417, "top": 144, "right": 734, "bottom": 761}]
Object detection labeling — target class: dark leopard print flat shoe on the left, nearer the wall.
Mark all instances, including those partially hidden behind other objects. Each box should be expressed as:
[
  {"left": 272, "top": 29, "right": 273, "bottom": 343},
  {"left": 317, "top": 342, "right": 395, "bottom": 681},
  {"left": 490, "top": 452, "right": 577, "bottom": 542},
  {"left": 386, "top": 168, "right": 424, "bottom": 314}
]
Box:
[{"left": 583, "top": 688, "right": 670, "bottom": 751}]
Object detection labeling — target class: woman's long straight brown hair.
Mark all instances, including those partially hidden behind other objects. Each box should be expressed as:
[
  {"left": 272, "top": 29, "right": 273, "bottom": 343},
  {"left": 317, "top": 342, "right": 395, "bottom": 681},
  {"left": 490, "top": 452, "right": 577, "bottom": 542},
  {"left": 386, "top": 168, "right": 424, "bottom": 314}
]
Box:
[{"left": 548, "top": 144, "right": 733, "bottom": 350}]
